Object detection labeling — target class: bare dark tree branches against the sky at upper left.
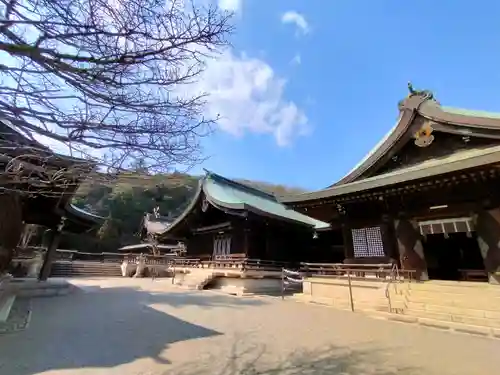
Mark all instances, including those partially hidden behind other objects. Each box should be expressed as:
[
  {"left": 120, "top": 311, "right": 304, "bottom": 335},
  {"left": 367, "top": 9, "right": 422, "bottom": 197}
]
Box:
[{"left": 0, "top": 0, "right": 232, "bottom": 172}]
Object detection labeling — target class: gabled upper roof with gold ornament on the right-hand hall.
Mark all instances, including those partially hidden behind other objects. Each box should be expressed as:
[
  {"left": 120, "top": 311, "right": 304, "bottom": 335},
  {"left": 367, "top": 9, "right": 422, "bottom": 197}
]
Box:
[{"left": 280, "top": 85, "right": 500, "bottom": 203}]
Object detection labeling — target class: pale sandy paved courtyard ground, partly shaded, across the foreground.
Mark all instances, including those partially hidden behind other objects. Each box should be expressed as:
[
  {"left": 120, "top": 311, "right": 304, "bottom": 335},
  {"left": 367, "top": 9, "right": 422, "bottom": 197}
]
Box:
[{"left": 0, "top": 279, "right": 500, "bottom": 375}]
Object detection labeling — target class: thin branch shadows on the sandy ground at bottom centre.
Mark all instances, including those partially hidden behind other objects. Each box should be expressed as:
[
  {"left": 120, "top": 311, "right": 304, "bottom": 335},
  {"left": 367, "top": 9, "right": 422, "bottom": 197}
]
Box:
[{"left": 169, "top": 343, "right": 424, "bottom": 375}]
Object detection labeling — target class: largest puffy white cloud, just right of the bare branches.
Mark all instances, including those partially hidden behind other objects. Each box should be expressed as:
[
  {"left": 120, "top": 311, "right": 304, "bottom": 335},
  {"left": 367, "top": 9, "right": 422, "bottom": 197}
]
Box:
[{"left": 197, "top": 50, "right": 309, "bottom": 146}]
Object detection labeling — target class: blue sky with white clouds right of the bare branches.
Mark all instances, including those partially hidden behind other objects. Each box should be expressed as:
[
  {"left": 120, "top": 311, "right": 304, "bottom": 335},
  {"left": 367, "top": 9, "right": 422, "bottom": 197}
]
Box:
[{"left": 196, "top": 0, "right": 500, "bottom": 190}]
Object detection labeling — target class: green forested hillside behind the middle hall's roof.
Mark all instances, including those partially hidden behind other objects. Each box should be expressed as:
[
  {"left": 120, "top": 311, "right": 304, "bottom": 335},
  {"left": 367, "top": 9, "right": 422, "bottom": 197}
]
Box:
[{"left": 59, "top": 171, "right": 302, "bottom": 252}]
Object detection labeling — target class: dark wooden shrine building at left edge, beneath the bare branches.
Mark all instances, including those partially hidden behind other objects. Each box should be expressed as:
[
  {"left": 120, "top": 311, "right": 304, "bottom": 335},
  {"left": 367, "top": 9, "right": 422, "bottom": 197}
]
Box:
[{"left": 0, "top": 120, "right": 104, "bottom": 280}]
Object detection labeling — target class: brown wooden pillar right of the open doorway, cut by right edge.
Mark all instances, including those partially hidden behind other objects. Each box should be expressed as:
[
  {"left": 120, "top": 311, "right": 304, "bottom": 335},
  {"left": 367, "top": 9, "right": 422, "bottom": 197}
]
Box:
[{"left": 476, "top": 208, "right": 500, "bottom": 284}]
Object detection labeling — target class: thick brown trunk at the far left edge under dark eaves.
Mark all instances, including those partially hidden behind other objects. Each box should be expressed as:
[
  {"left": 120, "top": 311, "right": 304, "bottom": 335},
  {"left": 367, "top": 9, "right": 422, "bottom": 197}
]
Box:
[{"left": 0, "top": 193, "right": 23, "bottom": 275}]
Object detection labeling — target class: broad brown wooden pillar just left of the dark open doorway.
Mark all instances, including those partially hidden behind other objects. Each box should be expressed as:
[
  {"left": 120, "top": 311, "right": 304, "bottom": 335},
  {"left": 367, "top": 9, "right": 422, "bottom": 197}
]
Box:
[{"left": 394, "top": 217, "right": 429, "bottom": 280}]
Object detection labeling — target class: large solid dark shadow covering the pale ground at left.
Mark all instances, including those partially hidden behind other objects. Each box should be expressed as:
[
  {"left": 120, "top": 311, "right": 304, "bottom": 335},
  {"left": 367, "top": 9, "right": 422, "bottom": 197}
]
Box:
[{"left": 0, "top": 288, "right": 229, "bottom": 375}]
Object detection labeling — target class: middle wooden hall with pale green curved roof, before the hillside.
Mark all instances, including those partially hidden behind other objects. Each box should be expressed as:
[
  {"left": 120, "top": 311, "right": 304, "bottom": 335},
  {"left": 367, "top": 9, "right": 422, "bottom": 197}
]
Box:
[{"left": 158, "top": 172, "right": 329, "bottom": 262}]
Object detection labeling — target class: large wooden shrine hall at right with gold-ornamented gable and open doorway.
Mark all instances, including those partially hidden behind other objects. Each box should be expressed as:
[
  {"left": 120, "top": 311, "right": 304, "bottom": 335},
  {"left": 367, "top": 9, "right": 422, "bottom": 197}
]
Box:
[{"left": 280, "top": 84, "right": 500, "bottom": 283}]
